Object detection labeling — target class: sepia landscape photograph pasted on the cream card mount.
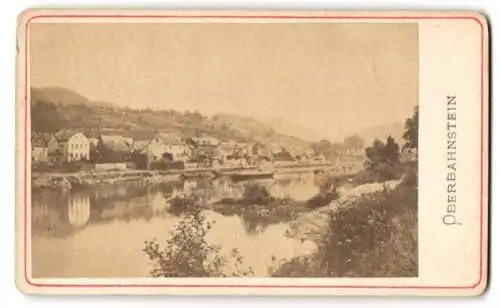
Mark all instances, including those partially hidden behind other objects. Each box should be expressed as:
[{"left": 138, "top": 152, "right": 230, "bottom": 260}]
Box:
[{"left": 27, "top": 21, "right": 419, "bottom": 278}]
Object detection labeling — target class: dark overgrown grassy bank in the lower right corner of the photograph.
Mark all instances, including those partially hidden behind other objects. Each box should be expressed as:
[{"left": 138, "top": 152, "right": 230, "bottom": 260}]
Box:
[{"left": 271, "top": 166, "right": 418, "bottom": 277}]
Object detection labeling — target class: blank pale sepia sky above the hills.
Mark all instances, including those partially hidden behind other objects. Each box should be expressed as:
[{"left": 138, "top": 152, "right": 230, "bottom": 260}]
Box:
[{"left": 29, "top": 23, "right": 418, "bottom": 139}]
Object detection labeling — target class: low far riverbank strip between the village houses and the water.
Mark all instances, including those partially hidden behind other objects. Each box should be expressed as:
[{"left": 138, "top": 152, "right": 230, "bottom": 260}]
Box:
[{"left": 31, "top": 163, "right": 352, "bottom": 189}]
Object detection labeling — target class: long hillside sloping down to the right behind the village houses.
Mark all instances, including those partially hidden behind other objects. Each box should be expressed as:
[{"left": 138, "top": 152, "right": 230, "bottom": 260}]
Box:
[{"left": 31, "top": 88, "right": 308, "bottom": 147}]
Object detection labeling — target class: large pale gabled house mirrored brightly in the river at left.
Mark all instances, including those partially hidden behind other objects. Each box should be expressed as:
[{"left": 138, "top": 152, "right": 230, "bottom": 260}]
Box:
[{"left": 54, "top": 130, "right": 90, "bottom": 161}]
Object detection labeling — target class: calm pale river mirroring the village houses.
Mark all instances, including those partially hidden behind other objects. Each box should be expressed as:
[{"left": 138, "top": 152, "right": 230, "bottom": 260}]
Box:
[{"left": 31, "top": 173, "right": 319, "bottom": 278}]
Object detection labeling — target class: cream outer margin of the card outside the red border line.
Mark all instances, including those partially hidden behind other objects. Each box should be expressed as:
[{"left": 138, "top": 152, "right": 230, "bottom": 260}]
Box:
[{"left": 15, "top": 9, "right": 489, "bottom": 296}]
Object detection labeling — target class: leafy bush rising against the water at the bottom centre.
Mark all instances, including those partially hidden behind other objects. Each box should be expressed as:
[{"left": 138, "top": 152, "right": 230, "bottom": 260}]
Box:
[{"left": 143, "top": 207, "right": 253, "bottom": 277}]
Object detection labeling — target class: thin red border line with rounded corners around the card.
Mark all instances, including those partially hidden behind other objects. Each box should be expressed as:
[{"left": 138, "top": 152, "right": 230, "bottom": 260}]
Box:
[{"left": 24, "top": 14, "right": 485, "bottom": 289}]
